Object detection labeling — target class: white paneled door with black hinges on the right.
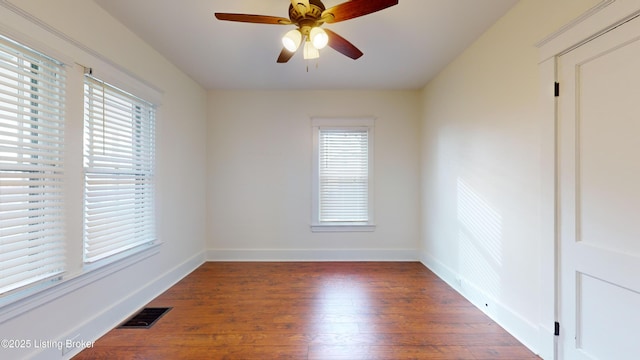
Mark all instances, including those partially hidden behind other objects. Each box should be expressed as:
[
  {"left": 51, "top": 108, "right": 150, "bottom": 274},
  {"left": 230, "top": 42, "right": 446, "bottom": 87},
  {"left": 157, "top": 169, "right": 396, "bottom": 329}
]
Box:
[{"left": 558, "top": 14, "right": 640, "bottom": 360}]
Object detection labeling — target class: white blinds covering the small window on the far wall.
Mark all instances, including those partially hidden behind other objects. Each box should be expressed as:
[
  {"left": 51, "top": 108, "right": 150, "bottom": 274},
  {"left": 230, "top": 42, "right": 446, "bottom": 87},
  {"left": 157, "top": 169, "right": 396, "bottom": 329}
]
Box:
[{"left": 318, "top": 128, "right": 370, "bottom": 224}]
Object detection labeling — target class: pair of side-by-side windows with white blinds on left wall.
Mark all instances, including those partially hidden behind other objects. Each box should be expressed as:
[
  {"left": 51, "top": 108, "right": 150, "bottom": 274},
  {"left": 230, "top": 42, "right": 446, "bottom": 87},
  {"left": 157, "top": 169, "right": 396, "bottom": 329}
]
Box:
[{"left": 0, "top": 29, "right": 162, "bottom": 314}]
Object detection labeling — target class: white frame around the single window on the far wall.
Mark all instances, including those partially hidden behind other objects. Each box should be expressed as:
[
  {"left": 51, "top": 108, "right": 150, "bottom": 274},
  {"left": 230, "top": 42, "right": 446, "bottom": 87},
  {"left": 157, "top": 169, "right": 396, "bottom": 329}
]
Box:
[{"left": 311, "top": 117, "right": 375, "bottom": 232}]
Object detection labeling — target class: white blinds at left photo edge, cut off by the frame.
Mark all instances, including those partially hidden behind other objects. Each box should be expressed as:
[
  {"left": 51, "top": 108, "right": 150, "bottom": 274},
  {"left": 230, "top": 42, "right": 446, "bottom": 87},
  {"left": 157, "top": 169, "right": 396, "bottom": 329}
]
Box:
[{"left": 0, "top": 37, "right": 65, "bottom": 295}]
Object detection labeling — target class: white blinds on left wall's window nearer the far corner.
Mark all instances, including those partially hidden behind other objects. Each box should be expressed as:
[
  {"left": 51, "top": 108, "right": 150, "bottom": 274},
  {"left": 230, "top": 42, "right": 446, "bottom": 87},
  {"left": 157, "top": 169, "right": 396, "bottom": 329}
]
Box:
[{"left": 84, "top": 76, "right": 156, "bottom": 263}]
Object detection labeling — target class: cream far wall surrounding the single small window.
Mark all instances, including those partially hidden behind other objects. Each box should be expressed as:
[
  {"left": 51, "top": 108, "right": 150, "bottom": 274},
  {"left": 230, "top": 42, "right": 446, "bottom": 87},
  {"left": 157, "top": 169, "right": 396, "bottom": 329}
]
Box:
[{"left": 207, "top": 91, "right": 420, "bottom": 260}]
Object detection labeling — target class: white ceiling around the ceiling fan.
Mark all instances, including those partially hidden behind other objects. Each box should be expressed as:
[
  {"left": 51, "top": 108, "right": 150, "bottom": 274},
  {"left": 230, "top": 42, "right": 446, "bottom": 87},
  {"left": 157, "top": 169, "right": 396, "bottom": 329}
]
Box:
[{"left": 94, "top": 0, "right": 518, "bottom": 89}]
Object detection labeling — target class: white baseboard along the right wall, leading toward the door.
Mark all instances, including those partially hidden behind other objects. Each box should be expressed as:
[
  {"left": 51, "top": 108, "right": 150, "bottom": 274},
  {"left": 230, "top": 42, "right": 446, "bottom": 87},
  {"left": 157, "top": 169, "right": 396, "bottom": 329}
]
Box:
[{"left": 421, "top": 253, "right": 552, "bottom": 359}]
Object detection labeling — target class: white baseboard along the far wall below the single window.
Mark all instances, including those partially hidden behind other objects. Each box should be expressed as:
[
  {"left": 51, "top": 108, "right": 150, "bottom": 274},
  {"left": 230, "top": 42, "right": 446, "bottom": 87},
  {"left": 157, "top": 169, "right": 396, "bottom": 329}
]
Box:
[{"left": 206, "top": 249, "right": 418, "bottom": 261}]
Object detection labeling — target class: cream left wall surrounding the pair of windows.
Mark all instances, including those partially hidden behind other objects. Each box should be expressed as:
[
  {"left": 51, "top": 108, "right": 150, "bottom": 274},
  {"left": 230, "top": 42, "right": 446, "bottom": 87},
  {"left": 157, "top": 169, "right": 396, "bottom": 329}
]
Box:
[{"left": 0, "top": 0, "right": 207, "bottom": 359}]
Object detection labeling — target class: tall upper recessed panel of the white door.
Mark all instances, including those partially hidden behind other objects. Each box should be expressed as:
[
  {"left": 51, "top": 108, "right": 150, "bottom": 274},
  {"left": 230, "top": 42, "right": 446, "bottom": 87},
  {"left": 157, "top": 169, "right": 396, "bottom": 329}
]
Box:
[{"left": 575, "top": 35, "right": 640, "bottom": 254}]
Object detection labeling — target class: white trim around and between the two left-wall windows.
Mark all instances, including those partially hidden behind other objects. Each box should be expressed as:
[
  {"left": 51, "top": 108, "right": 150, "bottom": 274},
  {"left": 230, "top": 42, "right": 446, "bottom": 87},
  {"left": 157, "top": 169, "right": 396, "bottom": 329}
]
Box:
[{"left": 0, "top": 16, "right": 164, "bottom": 324}]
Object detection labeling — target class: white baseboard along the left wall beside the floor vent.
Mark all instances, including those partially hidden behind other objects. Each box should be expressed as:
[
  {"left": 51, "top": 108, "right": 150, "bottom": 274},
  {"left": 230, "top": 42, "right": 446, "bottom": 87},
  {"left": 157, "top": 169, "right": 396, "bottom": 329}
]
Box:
[{"left": 30, "top": 252, "right": 204, "bottom": 360}]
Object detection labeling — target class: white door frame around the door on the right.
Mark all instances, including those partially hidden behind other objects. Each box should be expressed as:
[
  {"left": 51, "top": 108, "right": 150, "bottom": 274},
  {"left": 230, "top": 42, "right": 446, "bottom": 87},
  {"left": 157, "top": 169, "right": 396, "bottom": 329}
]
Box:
[{"left": 536, "top": 0, "right": 640, "bottom": 360}]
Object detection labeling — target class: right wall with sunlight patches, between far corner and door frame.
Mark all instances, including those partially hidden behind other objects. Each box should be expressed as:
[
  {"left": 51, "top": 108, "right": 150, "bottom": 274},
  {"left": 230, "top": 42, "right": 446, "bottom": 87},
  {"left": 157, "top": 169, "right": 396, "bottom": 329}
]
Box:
[{"left": 421, "top": 0, "right": 599, "bottom": 357}]
